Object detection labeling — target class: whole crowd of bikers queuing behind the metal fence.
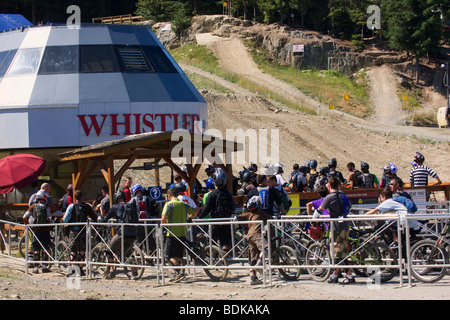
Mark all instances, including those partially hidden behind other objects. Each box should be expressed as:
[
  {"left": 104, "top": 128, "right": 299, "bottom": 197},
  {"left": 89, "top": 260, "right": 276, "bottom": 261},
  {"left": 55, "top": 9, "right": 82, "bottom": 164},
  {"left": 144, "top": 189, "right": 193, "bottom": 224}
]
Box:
[{"left": 23, "top": 152, "right": 441, "bottom": 285}]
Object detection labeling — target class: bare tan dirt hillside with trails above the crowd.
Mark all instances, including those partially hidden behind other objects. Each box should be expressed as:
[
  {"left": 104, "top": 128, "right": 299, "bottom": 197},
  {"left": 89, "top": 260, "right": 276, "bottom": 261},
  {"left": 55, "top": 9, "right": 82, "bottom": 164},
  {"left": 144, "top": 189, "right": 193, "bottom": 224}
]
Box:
[{"left": 163, "top": 16, "right": 450, "bottom": 185}]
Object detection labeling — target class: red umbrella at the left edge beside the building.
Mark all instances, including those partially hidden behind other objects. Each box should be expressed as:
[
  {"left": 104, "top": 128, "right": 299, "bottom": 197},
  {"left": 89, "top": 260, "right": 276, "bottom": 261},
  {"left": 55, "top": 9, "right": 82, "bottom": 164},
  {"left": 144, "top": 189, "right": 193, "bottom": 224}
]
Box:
[{"left": 0, "top": 154, "right": 45, "bottom": 194}]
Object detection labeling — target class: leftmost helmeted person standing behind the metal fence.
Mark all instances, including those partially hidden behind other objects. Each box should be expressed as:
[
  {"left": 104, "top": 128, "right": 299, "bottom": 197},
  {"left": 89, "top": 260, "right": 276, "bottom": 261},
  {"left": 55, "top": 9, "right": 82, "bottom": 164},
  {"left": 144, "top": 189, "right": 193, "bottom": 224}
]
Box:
[{"left": 23, "top": 190, "right": 63, "bottom": 273}]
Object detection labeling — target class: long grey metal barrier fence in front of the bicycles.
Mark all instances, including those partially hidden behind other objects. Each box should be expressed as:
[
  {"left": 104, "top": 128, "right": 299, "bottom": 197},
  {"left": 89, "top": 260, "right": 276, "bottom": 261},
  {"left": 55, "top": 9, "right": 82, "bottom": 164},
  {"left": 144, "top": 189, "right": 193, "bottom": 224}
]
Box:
[{"left": 0, "top": 202, "right": 450, "bottom": 286}]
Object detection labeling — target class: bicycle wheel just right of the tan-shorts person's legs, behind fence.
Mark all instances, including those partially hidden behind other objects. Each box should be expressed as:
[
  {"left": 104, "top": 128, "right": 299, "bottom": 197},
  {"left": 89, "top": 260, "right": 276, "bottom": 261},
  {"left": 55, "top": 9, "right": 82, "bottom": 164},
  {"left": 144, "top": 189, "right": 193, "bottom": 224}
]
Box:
[{"left": 271, "top": 245, "right": 302, "bottom": 281}]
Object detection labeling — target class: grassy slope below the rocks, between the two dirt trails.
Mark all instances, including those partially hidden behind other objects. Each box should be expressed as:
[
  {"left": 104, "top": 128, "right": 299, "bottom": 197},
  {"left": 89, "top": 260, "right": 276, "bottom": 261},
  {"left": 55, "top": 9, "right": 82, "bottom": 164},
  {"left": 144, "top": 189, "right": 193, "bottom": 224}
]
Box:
[{"left": 246, "top": 41, "right": 373, "bottom": 118}]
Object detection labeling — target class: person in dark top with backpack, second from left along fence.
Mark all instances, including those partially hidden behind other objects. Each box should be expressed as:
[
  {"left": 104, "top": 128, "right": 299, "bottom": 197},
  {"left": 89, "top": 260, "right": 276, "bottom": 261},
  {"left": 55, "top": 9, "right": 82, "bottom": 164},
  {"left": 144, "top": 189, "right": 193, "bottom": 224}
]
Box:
[{"left": 63, "top": 190, "right": 97, "bottom": 274}]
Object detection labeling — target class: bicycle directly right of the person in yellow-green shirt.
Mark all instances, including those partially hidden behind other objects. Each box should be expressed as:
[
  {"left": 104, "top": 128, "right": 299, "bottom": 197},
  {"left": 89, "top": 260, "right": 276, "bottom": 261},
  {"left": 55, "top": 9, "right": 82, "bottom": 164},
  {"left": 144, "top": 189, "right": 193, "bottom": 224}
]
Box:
[{"left": 166, "top": 233, "right": 228, "bottom": 281}]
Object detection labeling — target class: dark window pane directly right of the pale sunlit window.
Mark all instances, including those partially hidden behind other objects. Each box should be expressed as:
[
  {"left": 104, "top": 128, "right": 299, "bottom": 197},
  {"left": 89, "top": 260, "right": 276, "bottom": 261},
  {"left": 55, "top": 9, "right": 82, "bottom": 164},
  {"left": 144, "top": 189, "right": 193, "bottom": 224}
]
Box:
[{"left": 39, "top": 46, "right": 78, "bottom": 74}]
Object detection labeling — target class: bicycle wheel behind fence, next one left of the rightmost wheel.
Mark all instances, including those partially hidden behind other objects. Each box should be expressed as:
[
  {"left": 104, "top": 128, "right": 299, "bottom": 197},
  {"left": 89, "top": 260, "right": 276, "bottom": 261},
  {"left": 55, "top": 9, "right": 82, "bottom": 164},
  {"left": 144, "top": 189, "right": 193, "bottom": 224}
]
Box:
[{"left": 354, "top": 243, "right": 397, "bottom": 283}]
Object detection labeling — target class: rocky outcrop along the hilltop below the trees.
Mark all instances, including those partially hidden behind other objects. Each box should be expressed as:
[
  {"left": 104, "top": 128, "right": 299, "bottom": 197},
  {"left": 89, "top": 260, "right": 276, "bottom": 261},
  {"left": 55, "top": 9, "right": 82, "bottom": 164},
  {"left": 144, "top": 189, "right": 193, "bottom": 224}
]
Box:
[{"left": 154, "top": 15, "right": 412, "bottom": 75}]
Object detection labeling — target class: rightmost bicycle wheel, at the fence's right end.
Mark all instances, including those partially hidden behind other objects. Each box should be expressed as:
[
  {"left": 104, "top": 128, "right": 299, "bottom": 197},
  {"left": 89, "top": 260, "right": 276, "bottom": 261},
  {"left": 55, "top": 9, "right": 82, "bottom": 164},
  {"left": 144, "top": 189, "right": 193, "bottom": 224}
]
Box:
[{"left": 411, "top": 239, "right": 448, "bottom": 283}]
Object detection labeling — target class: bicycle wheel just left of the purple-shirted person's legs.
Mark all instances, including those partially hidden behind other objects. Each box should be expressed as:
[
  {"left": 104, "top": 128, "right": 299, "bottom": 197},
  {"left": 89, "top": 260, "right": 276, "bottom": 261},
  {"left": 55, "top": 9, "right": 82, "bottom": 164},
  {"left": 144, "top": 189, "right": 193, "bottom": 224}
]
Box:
[{"left": 306, "top": 242, "right": 331, "bottom": 282}]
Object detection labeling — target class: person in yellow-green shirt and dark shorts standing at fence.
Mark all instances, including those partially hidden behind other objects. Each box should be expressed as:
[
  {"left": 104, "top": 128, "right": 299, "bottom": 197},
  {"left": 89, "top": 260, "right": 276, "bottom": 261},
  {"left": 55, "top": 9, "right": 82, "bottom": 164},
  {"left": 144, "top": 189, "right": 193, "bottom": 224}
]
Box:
[{"left": 161, "top": 188, "right": 197, "bottom": 282}]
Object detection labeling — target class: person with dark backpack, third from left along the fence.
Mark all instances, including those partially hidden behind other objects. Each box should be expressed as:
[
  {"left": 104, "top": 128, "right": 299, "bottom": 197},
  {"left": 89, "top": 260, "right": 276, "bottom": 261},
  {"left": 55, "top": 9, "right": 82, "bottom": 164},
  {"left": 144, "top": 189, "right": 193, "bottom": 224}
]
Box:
[{"left": 102, "top": 190, "right": 138, "bottom": 279}]
